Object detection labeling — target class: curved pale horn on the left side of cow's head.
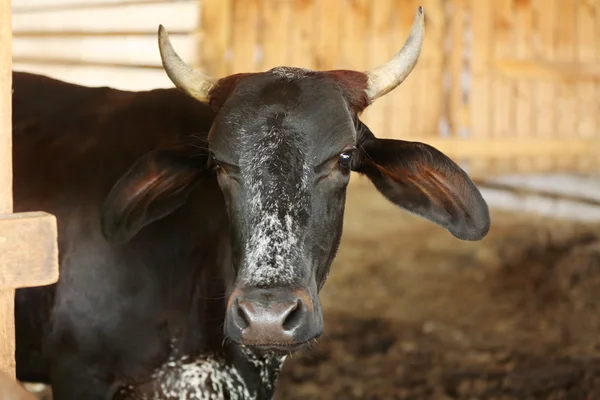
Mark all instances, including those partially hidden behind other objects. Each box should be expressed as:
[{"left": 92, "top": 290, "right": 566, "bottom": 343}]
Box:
[{"left": 158, "top": 25, "right": 217, "bottom": 102}]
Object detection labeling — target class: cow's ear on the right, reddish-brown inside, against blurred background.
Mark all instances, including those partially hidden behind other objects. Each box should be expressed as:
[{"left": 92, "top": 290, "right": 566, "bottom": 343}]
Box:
[{"left": 353, "top": 123, "right": 490, "bottom": 240}]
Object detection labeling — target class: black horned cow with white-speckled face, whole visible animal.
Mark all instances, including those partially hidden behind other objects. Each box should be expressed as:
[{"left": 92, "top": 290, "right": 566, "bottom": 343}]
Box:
[{"left": 13, "top": 7, "right": 490, "bottom": 400}]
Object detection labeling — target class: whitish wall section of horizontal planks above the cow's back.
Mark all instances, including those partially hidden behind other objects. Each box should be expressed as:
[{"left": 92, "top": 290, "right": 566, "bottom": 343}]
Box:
[{"left": 13, "top": 0, "right": 201, "bottom": 90}]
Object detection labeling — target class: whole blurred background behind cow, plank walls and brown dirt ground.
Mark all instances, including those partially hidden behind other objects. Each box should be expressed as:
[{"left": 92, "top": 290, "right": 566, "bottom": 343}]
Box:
[{"left": 13, "top": 0, "right": 600, "bottom": 399}]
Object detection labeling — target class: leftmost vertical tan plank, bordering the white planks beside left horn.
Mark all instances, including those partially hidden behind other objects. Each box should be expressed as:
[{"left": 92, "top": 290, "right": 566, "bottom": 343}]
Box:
[{"left": 200, "top": 0, "right": 233, "bottom": 78}]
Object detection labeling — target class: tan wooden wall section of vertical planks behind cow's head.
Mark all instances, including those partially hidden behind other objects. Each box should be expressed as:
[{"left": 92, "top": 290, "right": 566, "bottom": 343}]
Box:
[{"left": 202, "top": 0, "right": 600, "bottom": 175}]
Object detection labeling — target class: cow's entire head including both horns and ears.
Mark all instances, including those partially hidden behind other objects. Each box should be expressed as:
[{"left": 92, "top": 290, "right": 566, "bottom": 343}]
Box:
[{"left": 105, "top": 8, "right": 490, "bottom": 351}]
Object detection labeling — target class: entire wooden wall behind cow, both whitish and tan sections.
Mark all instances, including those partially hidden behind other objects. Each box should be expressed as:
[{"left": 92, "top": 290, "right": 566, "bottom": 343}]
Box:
[{"left": 13, "top": 0, "right": 600, "bottom": 175}]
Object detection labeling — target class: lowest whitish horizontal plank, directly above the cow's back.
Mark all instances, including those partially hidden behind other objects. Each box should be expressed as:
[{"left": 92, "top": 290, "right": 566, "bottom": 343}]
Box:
[{"left": 14, "top": 63, "right": 174, "bottom": 90}]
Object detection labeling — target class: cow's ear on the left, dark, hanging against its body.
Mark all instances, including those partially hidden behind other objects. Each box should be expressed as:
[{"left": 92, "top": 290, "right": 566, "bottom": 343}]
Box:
[{"left": 100, "top": 148, "right": 207, "bottom": 243}]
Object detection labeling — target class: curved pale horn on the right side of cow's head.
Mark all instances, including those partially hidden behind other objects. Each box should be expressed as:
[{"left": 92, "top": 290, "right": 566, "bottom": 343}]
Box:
[{"left": 367, "top": 6, "right": 425, "bottom": 102}]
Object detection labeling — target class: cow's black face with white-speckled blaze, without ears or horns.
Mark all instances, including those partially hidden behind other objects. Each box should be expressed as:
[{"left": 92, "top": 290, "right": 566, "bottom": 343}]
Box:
[{"left": 209, "top": 68, "right": 360, "bottom": 349}]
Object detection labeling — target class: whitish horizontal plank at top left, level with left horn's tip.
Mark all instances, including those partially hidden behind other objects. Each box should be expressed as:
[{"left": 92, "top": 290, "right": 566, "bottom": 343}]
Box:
[{"left": 13, "top": 1, "right": 200, "bottom": 32}]
